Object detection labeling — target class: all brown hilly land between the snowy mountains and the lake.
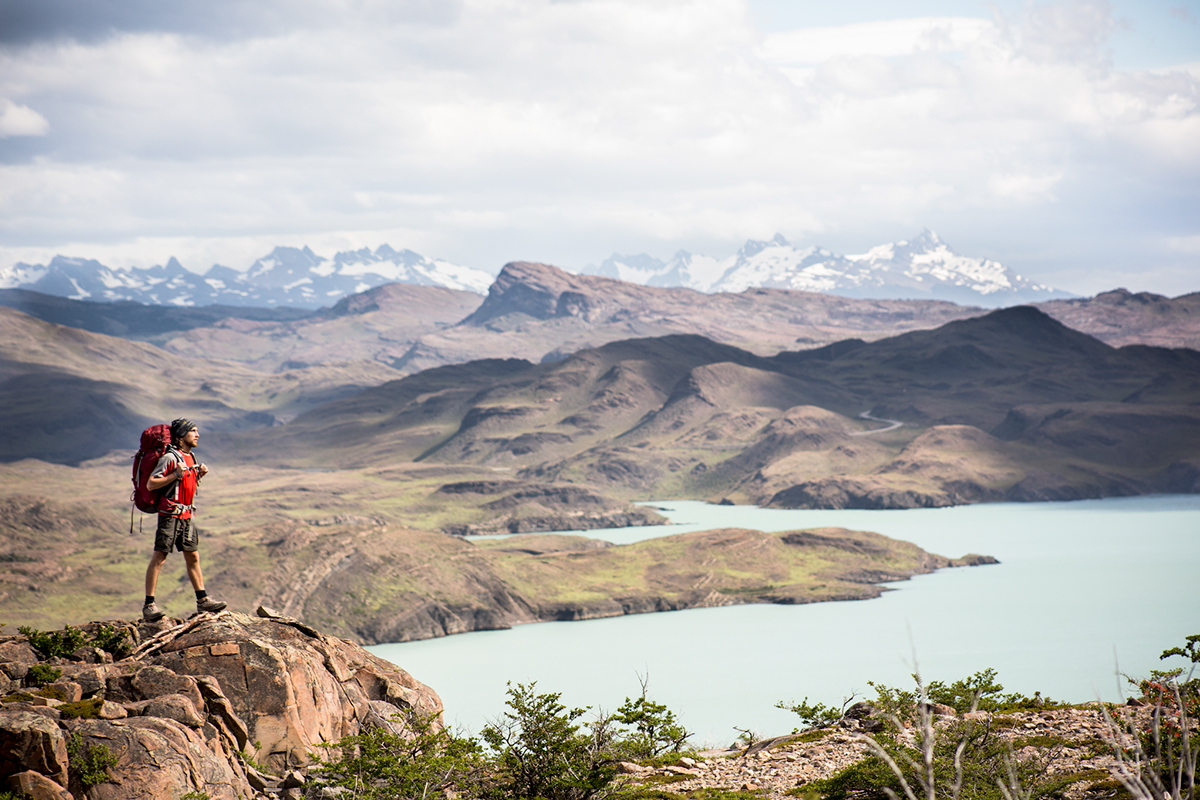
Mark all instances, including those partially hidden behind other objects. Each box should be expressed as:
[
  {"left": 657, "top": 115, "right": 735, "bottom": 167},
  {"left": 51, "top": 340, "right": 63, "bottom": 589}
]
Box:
[{"left": 0, "top": 263, "right": 1200, "bottom": 642}]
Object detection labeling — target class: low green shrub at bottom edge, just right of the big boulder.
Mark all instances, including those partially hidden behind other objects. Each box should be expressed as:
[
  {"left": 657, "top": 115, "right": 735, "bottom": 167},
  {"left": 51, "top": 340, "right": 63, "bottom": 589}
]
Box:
[{"left": 314, "top": 710, "right": 482, "bottom": 800}]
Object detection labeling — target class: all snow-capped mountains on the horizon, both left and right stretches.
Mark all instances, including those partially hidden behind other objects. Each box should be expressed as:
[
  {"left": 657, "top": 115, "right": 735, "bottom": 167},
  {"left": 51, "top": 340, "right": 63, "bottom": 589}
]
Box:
[{"left": 0, "top": 230, "right": 1074, "bottom": 308}]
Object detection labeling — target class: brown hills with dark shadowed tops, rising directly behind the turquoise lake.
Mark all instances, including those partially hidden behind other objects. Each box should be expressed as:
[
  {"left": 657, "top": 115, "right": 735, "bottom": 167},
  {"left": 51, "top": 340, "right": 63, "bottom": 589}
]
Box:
[{"left": 235, "top": 303, "right": 1200, "bottom": 507}]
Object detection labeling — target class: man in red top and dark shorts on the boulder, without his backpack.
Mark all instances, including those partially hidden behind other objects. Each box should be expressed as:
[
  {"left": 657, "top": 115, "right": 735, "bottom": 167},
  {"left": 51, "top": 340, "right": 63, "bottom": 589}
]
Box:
[{"left": 142, "top": 419, "right": 226, "bottom": 622}]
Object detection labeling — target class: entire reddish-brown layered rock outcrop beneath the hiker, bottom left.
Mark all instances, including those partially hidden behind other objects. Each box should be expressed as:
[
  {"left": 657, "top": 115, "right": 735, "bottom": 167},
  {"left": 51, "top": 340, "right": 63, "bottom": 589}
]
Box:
[{"left": 0, "top": 608, "right": 442, "bottom": 800}]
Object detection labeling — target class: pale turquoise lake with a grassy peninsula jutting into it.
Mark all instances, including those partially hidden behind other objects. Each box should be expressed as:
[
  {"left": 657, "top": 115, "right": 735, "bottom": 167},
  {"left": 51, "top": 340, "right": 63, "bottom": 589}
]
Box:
[{"left": 370, "top": 495, "right": 1200, "bottom": 745}]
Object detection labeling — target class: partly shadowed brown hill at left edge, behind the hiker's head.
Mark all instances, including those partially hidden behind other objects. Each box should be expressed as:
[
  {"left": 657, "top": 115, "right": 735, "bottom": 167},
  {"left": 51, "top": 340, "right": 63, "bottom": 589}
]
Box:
[{"left": 0, "top": 307, "right": 392, "bottom": 463}]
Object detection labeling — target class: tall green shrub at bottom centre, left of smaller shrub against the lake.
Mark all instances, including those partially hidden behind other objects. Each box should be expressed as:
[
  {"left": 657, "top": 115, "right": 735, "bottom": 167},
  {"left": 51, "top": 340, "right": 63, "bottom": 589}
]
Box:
[{"left": 481, "top": 684, "right": 617, "bottom": 800}]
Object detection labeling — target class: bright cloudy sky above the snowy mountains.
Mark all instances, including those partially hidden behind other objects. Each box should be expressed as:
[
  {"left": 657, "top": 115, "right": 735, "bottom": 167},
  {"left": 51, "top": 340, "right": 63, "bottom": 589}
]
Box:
[{"left": 0, "top": 0, "right": 1200, "bottom": 295}]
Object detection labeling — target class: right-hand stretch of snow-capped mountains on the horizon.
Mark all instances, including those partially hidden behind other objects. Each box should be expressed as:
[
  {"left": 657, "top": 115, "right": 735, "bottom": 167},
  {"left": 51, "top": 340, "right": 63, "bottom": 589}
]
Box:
[{"left": 582, "top": 230, "right": 1073, "bottom": 308}]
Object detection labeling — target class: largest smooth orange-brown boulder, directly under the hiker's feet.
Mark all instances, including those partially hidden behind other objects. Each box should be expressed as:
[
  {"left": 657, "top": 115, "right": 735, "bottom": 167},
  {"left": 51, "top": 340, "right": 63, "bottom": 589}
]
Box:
[{"left": 130, "top": 609, "right": 442, "bottom": 771}]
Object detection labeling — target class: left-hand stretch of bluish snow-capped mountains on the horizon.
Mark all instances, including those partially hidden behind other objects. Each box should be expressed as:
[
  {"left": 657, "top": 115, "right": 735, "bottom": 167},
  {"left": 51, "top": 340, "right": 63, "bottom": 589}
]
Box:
[{"left": 0, "top": 245, "right": 492, "bottom": 308}]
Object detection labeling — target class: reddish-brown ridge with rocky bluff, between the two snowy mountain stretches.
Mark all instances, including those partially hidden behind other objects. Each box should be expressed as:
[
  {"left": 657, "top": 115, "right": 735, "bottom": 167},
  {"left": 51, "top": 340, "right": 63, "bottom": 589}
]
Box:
[{"left": 396, "top": 261, "right": 984, "bottom": 372}]
